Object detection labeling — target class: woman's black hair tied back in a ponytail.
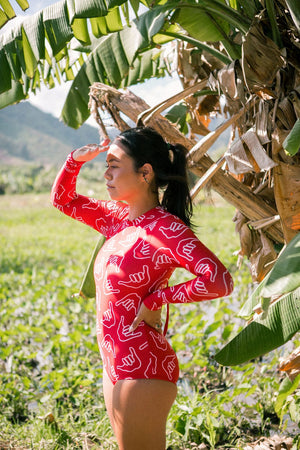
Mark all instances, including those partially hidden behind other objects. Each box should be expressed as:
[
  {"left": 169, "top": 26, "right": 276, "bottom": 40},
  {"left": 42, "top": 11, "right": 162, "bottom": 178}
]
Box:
[{"left": 116, "top": 127, "right": 193, "bottom": 226}]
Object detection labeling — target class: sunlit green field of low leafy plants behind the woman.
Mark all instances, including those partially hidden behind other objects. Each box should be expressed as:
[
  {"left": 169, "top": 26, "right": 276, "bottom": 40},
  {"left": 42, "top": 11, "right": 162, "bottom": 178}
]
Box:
[{"left": 0, "top": 194, "right": 298, "bottom": 450}]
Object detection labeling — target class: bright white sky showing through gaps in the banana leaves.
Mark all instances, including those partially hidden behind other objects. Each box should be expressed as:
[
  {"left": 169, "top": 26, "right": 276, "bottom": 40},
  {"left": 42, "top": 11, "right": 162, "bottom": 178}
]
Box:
[{"left": 1, "top": 0, "right": 182, "bottom": 126}]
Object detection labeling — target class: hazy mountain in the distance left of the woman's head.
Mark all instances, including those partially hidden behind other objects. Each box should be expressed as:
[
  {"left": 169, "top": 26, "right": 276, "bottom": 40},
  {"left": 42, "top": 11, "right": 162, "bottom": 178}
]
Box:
[{"left": 0, "top": 101, "right": 107, "bottom": 165}]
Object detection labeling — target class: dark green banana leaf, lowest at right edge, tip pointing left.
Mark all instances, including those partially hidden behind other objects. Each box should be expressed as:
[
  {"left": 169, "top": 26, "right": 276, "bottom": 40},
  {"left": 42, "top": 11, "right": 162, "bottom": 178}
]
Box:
[{"left": 215, "top": 288, "right": 300, "bottom": 366}]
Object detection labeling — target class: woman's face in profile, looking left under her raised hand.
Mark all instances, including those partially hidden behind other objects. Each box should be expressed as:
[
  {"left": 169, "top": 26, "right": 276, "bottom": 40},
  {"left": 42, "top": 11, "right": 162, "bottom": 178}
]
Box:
[{"left": 104, "top": 144, "right": 145, "bottom": 203}]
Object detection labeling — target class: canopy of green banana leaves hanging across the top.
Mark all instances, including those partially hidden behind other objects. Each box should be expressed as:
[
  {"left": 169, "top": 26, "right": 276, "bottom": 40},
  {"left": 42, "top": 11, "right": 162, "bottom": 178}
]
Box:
[{"left": 0, "top": 0, "right": 256, "bottom": 128}]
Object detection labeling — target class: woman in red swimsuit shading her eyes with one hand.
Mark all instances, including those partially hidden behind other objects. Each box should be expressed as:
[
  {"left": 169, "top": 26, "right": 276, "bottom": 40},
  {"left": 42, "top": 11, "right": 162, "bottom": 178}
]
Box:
[{"left": 52, "top": 127, "right": 233, "bottom": 450}]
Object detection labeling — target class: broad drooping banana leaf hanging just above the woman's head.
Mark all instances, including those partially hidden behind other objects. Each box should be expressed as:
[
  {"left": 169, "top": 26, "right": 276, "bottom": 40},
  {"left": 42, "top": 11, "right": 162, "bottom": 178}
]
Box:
[{"left": 61, "top": 33, "right": 168, "bottom": 128}]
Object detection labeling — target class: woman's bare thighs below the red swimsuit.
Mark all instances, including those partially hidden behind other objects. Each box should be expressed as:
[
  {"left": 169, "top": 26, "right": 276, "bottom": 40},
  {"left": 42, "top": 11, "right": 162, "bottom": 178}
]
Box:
[{"left": 103, "top": 375, "right": 177, "bottom": 450}]
